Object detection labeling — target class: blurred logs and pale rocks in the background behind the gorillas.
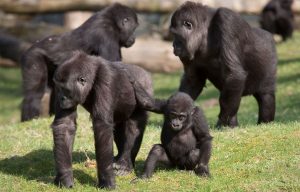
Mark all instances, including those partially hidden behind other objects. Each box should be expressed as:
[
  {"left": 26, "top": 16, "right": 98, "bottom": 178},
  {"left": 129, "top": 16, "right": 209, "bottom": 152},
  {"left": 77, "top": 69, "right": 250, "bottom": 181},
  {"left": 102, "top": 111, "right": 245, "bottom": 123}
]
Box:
[{"left": 0, "top": 0, "right": 300, "bottom": 72}]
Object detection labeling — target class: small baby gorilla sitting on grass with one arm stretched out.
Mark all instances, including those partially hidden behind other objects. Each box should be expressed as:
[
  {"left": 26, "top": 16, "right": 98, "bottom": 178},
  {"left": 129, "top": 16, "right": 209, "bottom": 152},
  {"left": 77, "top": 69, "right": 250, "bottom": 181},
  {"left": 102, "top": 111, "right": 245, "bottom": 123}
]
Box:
[{"left": 133, "top": 83, "right": 212, "bottom": 178}]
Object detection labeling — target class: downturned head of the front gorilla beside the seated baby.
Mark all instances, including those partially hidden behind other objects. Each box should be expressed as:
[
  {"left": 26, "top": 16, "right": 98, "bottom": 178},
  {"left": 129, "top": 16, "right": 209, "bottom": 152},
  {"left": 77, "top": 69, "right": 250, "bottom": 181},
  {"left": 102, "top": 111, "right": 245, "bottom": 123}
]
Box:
[{"left": 53, "top": 52, "right": 95, "bottom": 109}]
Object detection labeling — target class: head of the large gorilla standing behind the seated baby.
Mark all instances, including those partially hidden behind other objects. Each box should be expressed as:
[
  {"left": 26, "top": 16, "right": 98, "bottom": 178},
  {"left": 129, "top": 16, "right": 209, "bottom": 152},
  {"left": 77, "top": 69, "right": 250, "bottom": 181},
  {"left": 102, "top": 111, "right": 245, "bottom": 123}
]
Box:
[{"left": 170, "top": 2, "right": 209, "bottom": 60}]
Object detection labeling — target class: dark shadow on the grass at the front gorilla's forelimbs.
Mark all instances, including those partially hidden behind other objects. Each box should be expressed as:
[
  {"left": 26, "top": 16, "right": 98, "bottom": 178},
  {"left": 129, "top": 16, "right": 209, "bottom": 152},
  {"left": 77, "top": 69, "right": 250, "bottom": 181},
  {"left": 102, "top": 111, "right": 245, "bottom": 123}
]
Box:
[{"left": 0, "top": 149, "right": 96, "bottom": 186}]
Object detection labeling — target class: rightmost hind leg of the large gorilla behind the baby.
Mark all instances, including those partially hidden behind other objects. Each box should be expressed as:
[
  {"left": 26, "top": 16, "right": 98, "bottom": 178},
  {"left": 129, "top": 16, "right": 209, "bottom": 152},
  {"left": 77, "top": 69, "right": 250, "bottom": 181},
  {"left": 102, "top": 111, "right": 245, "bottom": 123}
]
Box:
[{"left": 254, "top": 93, "right": 275, "bottom": 124}]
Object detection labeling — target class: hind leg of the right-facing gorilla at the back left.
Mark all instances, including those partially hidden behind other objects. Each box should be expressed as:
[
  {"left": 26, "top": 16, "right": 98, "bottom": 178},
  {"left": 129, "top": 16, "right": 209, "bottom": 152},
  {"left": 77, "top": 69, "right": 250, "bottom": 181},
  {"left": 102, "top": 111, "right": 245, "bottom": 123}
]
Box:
[{"left": 21, "top": 50, "right": 48, "bottom": 121}]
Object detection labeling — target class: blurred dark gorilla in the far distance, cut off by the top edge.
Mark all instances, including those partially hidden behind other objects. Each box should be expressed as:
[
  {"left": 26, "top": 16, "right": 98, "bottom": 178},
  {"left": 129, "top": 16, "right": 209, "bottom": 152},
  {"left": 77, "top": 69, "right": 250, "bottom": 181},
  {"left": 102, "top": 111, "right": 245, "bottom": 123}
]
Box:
[{"left": 260, "top": 0, "right": 294, "bottom": 41}]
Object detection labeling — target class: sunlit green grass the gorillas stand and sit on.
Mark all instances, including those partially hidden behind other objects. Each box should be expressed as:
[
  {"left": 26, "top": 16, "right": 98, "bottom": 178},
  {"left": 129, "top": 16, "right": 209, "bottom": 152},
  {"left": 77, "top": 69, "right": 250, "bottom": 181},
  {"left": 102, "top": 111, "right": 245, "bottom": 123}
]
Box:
[{"left": 0, "top": 33, "right": 300, "bottom": 191}]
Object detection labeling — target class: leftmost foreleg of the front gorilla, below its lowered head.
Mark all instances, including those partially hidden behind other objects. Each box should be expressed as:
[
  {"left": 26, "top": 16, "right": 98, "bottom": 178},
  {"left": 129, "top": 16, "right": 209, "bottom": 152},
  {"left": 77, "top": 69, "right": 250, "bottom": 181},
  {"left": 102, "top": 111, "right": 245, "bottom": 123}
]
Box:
[{"left": 52, "top": 107, "right": 77, "bottom": 188}]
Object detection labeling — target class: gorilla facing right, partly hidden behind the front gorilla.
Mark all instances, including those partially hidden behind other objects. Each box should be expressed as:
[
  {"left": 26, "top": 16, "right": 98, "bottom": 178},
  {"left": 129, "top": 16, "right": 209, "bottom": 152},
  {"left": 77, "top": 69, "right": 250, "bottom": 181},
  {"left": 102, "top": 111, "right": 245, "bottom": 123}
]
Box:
[{"left": 21, "top": 3, "right": 138, "bottom": 121}]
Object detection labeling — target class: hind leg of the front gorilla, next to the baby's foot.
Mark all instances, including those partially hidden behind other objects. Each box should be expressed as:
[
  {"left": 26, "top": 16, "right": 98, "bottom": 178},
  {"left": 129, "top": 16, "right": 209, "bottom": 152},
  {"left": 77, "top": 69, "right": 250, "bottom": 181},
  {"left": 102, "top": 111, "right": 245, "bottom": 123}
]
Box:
[{"left": 114, "top": 110, "right": 147, "bottom": 175}]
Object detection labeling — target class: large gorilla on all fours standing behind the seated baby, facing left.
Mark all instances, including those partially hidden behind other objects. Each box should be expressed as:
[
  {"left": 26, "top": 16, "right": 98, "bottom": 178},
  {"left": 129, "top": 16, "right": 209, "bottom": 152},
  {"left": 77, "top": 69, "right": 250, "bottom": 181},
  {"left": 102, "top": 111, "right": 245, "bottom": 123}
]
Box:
[{"left": 170, "top": 2, "right": 277, "bottom": 127}]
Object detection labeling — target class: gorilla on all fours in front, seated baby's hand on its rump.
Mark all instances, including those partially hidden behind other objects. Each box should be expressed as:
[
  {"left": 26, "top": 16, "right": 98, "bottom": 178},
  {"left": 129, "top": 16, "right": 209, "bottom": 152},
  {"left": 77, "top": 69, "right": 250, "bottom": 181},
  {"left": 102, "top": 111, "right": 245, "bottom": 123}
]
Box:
[{"left": 52, "top": 52, "right": 152, "bottom": 188}]
